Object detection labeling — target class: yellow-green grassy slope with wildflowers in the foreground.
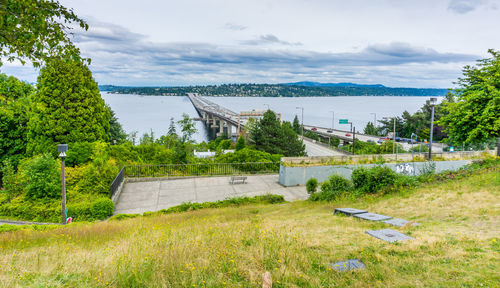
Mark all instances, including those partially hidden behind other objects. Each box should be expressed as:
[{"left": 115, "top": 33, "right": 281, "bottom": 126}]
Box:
[{"left": 0, "top": 171, "right": 500, "bottom": 287}]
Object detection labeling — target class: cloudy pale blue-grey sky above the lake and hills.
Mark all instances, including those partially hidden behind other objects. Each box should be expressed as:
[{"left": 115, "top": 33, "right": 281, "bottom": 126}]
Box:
[{"left": 1, "top": 0, "right": 500, "bottom": 88}]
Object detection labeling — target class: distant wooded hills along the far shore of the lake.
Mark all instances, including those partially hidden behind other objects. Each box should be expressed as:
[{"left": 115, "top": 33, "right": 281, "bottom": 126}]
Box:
[{"left": 99, "top": 82, "right": 448, "bottom": 97}]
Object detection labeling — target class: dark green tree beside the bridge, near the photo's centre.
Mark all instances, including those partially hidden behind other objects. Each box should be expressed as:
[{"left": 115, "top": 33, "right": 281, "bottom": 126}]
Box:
[{"left": 250, "top": 110, "right": 305, "bottom": 156}]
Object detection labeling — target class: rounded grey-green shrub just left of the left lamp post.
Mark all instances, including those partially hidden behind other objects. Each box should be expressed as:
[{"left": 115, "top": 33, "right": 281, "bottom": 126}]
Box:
[{"left": 21, "top": 154, "right": 61, "bottom": 199}]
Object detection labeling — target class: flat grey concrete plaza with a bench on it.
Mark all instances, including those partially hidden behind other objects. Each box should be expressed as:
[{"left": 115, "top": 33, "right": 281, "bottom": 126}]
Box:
[{"left": 115, "top": 175, "right": 308, "bottom": 214}]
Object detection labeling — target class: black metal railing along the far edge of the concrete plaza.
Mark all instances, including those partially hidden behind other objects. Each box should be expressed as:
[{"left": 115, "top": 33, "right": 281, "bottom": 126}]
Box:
[{"left": 124, "top": 162, "right": 280, "bottom": 177}]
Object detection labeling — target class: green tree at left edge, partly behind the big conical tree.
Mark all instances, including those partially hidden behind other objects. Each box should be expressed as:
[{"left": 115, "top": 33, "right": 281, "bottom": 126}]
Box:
[{"left": 0, "top": 74, "right": 34, "bottom": 178}]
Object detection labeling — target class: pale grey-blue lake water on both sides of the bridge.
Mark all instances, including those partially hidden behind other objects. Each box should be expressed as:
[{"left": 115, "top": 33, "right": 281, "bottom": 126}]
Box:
[{"left": 101, "top": 92, "right": 443, "bottom": 142}]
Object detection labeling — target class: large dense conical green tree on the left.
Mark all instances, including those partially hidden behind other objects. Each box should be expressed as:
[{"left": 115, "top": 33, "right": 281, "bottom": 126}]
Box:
[{"left": 27, "top": 58, "right": 110, "bottom": 155}]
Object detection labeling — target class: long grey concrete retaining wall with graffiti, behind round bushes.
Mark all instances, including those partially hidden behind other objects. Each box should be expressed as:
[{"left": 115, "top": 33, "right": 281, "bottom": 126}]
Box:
[{"left": 279, "top": 160, "right": 472, "bottom": 186}]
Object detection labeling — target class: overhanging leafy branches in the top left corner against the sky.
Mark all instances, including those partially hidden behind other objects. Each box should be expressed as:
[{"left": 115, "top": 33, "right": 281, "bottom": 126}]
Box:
[{"left": 0, "top": 0, "right": 88, "bottom": 67}]
